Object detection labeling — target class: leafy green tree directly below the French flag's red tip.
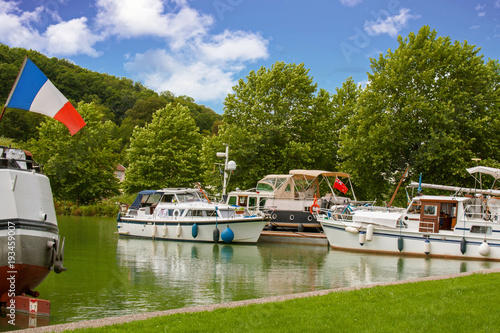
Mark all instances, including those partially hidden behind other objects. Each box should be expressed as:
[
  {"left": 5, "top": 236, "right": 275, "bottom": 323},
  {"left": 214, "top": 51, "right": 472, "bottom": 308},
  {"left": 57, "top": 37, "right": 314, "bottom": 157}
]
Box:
[{"left": 30, "top": 103, "right": 119, "bottom": 204}]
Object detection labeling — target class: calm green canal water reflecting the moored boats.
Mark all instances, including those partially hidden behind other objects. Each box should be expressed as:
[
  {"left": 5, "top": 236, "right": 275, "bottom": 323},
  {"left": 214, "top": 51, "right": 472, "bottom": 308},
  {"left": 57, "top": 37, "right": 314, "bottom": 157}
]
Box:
[{"left": 1, "top": 216, "right": 500, "bottom": 331}]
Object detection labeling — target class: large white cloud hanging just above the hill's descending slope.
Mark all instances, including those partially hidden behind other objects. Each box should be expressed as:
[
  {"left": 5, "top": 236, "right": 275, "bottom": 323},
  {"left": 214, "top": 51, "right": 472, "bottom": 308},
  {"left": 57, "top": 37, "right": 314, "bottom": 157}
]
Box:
[{"left": 125, "top": 27, "right": 268, "bottom": 101}]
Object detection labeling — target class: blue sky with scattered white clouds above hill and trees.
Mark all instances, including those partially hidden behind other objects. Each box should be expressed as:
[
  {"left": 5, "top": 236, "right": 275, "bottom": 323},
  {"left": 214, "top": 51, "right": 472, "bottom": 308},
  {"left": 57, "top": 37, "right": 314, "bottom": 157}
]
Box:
[{"left": 0, "top": 0, "right": 500, "bottom": 113}]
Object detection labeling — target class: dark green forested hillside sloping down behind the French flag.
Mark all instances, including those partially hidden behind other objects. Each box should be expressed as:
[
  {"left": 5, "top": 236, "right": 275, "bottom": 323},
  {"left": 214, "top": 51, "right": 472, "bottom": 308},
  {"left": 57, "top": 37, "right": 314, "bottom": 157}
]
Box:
[{"left": 0, "top": 44, "right": 222, "bottom": 141}]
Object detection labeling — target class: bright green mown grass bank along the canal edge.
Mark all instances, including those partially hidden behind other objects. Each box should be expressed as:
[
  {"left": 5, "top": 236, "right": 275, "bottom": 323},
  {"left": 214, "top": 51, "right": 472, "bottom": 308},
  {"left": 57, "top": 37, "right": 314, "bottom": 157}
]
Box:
[{"left": 68, "top": 273, "right": 500, "bottom": 333}]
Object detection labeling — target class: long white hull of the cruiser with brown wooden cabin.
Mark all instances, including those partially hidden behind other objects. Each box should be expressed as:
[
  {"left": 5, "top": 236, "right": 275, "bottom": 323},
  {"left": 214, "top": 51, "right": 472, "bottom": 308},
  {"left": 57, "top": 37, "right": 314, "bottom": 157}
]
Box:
[{"left": 320, "top": 219, "right": 500, "bottom": 261}]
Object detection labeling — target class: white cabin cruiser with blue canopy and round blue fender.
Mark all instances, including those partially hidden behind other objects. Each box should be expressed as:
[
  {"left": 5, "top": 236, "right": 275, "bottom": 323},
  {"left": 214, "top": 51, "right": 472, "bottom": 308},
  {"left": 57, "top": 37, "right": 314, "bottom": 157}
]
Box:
[{"left": 117, "top": 188, "right": 267, "bottom": 243}]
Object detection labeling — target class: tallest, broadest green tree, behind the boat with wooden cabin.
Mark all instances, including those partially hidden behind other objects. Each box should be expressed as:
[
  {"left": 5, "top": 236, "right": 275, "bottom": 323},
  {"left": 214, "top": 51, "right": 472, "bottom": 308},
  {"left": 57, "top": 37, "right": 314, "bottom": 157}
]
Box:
[{"left": 340, "top": 26, "right": 500, "bottom": 199}]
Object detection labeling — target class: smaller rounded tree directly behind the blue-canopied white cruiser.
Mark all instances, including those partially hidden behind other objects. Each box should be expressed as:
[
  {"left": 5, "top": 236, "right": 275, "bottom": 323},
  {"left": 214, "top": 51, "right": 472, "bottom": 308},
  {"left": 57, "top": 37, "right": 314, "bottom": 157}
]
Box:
[{"left": 123, "top": 104, "right": 201, "bottom": 193}]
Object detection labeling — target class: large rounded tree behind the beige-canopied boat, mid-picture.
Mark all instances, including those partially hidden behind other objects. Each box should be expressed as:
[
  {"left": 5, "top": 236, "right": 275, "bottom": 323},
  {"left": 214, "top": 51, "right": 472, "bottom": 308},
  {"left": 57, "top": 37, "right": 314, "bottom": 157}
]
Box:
[{"left": 211, "top": 62, "right": 344, "bottom": 188}]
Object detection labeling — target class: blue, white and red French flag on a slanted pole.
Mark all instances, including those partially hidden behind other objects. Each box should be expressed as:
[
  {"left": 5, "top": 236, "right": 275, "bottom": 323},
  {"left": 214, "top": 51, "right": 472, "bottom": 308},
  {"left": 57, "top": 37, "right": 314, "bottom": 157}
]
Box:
[{"left": 5, "top": 57, "right": 85, "bottom": 135}]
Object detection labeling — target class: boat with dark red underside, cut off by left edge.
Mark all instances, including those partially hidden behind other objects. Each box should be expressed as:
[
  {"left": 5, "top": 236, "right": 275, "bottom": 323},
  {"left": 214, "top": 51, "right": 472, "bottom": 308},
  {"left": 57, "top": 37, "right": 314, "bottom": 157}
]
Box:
[{"left": 0, "top": 146, "right": 65, "bottom": 304}]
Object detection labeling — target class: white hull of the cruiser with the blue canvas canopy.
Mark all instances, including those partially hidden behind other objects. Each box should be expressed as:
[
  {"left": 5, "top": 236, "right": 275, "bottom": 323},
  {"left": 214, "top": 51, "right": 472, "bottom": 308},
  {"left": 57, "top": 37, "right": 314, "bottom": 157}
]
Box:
[{"left": 118, "top": 217, "right": 267, "bottom": 244}]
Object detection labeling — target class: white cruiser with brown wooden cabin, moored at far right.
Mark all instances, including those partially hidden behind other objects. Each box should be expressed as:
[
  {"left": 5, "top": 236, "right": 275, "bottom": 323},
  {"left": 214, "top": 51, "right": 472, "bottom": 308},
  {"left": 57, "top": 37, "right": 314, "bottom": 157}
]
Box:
[{"left": 317, "top": 166, "right": 500, "bottom": 260}]
